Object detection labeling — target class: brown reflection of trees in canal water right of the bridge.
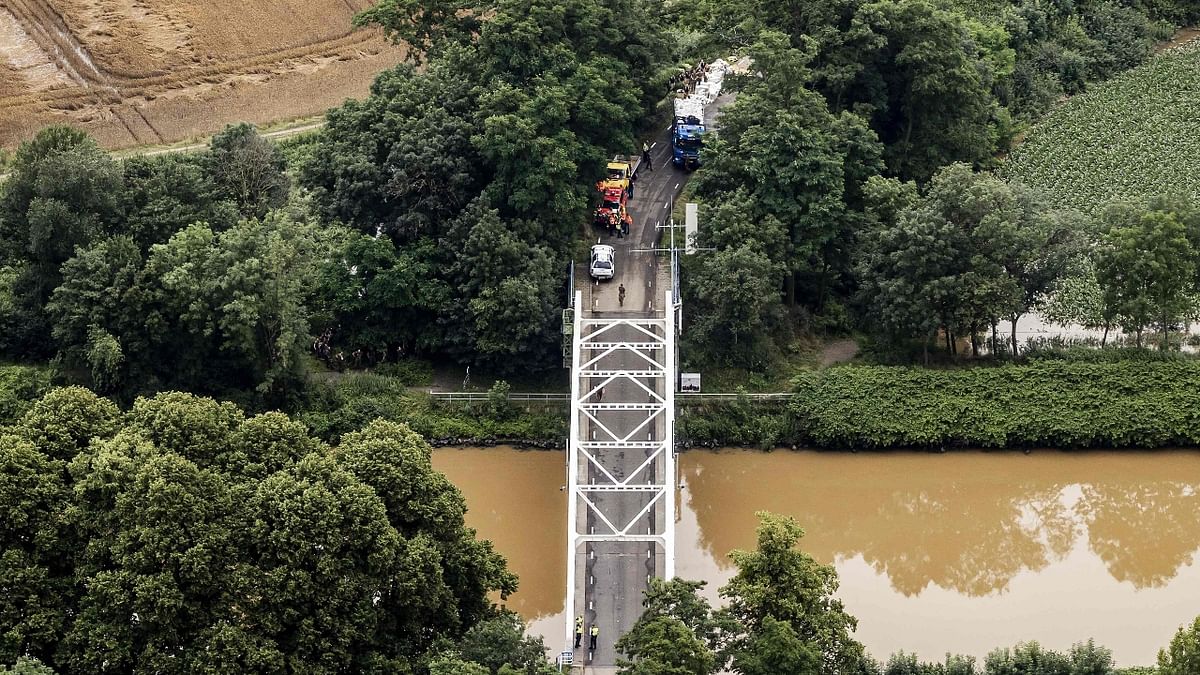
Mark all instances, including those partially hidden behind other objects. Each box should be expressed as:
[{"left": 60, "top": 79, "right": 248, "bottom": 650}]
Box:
[{"left": 683, "top": 452, "right": 1200, "bottom": 596}]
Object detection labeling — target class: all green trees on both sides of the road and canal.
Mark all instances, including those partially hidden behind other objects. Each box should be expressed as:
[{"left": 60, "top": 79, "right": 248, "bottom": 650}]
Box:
[{"left": 0, "top": 0, "right": 1200, "bottom": 675}]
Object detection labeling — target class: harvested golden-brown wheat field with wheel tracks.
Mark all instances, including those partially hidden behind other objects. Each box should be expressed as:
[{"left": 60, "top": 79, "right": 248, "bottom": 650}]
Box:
[{"left": 0, "top": 0, "right": 404, "bottom": 148}]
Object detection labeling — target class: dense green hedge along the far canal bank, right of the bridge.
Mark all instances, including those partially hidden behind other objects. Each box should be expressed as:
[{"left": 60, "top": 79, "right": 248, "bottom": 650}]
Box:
[{"left": 678, "top": 360, "right": 1200, "bottom": 449}]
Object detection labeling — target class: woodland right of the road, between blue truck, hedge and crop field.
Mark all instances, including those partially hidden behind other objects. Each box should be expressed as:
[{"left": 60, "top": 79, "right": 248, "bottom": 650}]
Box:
[{"left": 677, "top": 0, "right": 1200, "bottom": 371}]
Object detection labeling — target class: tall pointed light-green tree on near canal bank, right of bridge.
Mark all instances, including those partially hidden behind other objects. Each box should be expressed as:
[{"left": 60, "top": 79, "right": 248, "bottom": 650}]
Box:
[{"left": 720, "top": 512, "right": 864, "bottom": 673}]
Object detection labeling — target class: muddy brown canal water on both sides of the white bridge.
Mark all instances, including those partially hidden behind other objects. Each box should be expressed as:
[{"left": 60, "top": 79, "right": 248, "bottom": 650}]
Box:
[{"left": 433, "top": 447, "right": 1200, "bottom": 665}]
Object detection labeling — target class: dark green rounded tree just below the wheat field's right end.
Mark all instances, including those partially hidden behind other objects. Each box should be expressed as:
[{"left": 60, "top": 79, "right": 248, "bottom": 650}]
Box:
[{"left": 301, "top": 52, "right": 485, "bottom": 239}]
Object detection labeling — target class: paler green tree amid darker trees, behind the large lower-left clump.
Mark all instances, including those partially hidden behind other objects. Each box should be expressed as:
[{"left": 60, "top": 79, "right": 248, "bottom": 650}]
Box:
[{"left": 135, "top": 213, "right": 325, "bottom": 400}]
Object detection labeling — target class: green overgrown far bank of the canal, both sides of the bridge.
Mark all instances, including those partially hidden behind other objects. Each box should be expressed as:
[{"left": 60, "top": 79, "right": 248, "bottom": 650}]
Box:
[{"left": 14, "top": 354, "right": 1200, "bottom": 452}]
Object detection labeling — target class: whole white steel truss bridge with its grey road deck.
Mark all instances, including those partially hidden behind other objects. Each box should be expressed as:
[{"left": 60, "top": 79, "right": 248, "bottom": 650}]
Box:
[{"left": 564, "top": 291, "right": 678, "bottom": 667}]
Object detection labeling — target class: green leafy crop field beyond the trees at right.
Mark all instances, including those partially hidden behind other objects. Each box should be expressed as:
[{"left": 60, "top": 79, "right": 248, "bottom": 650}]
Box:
[{"left": 1004, "top": 40, "right": 1200, "bottom": 214}]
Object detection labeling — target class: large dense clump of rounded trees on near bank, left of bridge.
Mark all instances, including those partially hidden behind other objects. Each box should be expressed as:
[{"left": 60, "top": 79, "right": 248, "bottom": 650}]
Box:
[{"left": 0, "top": 388, "right": 518, "bottom": 673}]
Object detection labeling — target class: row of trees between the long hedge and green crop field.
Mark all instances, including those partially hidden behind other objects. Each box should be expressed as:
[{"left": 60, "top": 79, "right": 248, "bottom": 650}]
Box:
[{"left": 858, "top": 165, "right": 1200, "bottom": 353}]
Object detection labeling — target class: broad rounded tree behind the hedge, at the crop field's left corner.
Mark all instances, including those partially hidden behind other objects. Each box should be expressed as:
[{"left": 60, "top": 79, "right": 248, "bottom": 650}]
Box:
[{"left": 858, "top": 165, "right": 1090, "bottom": 352}]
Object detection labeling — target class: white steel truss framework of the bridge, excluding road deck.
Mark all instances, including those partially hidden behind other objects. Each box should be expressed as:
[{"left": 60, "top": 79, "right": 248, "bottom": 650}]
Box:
[{"left": 565, "top": 291, "right": 676, "bottom": 645}]
